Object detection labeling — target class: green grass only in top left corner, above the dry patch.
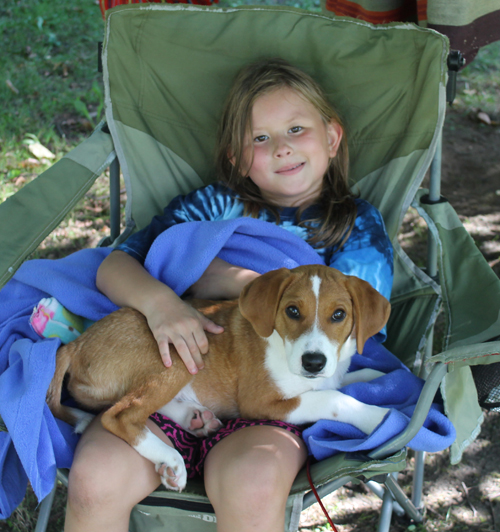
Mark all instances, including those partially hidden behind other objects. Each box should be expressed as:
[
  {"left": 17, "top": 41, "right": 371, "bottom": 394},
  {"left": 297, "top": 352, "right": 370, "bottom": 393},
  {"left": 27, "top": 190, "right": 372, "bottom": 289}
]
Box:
[{"left": 0, "top": 0, "right": 103, "bottom": 146}]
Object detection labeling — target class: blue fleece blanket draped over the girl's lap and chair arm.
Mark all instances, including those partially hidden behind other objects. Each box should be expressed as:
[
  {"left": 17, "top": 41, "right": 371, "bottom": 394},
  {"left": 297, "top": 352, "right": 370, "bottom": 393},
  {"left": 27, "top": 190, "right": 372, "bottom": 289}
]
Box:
[{"left": 0, "top": 218, "right": 454, "bottom": 518}]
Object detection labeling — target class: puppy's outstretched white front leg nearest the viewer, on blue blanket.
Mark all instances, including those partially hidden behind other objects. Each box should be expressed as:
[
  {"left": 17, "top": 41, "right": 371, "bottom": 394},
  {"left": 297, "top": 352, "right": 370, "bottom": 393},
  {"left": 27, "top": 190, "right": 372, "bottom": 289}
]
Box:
[{"left": 286, "top": 390, "right": 389, "bottom": 434}]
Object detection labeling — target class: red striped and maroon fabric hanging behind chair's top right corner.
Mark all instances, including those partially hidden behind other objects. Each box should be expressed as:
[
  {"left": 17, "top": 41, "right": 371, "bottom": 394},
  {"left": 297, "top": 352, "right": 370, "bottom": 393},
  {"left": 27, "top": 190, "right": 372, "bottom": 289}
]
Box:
[{"left": 323, "top": 0, "right": 500, "bottom": 63}]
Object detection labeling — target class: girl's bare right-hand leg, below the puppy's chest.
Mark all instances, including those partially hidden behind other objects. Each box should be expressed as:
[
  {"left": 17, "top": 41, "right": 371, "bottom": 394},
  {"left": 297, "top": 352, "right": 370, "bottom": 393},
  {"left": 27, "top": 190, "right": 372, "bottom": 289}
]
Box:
[{"left": 205, "top": 426, "right": 307, "bottom": 532}]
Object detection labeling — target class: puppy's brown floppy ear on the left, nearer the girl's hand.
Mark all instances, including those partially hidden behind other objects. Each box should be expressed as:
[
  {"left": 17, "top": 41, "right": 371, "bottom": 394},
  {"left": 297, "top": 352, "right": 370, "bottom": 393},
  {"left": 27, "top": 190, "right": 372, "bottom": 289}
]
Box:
[{"left": 239, "top": 268, "right": 293, "bottom": 338}]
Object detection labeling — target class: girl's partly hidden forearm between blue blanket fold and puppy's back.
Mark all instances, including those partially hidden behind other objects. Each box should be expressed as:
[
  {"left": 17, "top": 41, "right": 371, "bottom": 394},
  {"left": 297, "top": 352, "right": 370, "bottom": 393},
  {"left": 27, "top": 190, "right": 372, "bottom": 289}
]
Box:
[{"left": 186, "top": 257, "right": 260, "bottom": 299}]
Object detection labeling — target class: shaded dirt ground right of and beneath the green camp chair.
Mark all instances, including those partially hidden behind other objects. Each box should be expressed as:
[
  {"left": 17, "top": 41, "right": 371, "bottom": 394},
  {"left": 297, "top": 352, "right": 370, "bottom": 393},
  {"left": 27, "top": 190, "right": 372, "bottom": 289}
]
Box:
[{"left": 300, "top": 110, "right": 500, "bottom": 532}]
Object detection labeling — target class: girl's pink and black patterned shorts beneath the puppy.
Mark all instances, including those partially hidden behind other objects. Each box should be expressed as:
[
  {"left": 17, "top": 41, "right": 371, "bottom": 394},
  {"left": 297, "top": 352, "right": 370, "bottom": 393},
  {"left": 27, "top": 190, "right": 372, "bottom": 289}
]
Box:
[{"left": 149, "top": 412, "right": 302, "bottom": 478}]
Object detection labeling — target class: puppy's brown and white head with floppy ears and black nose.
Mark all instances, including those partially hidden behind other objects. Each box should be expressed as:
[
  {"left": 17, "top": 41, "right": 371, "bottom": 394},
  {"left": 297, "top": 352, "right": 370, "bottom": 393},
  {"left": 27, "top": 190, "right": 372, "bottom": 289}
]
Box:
[{"left": 239, "top": 265, "right": 390, "bottom": 378}]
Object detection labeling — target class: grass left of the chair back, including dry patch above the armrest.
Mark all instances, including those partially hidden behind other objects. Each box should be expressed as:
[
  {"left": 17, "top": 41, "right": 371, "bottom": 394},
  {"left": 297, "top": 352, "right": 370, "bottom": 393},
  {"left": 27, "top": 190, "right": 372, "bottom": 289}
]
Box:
[{"left": 0, "top": 0, "right": 103, "bottom": 209}]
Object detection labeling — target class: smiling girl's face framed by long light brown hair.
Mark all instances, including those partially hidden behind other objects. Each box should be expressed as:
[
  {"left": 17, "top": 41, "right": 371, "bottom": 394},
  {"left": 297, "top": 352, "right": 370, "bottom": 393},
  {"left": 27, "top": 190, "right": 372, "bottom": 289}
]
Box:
[{"left": 236, "top": 87, "right": 342, "bottom": 207}]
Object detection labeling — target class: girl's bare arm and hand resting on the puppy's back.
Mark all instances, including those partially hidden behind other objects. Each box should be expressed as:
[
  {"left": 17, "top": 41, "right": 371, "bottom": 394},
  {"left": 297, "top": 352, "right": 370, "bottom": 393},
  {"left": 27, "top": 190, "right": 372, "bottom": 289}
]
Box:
[{"left": 96, "top": 250, "right": 223, "bottom": 374}]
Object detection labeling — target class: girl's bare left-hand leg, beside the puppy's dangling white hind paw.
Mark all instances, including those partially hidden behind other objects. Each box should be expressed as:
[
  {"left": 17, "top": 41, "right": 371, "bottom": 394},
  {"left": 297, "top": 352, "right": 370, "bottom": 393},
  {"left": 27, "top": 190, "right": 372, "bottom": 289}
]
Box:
[{"left": 64, "top": 417, "right": 171, "bottom": 532}]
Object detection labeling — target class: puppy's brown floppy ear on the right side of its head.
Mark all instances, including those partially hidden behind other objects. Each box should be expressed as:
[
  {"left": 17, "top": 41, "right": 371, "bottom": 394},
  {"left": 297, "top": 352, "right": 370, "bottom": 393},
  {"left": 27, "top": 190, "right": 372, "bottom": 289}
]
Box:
[{"left": 345, "top": 276, "right": 391, "bottom": 354}]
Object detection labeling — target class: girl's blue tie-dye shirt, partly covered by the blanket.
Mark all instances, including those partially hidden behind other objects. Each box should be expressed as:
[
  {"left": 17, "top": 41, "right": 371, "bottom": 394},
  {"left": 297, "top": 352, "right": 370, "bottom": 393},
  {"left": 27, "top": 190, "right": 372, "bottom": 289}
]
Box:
[{"left": 117, "top": 183, "right": 393, "bottom": 299}]
